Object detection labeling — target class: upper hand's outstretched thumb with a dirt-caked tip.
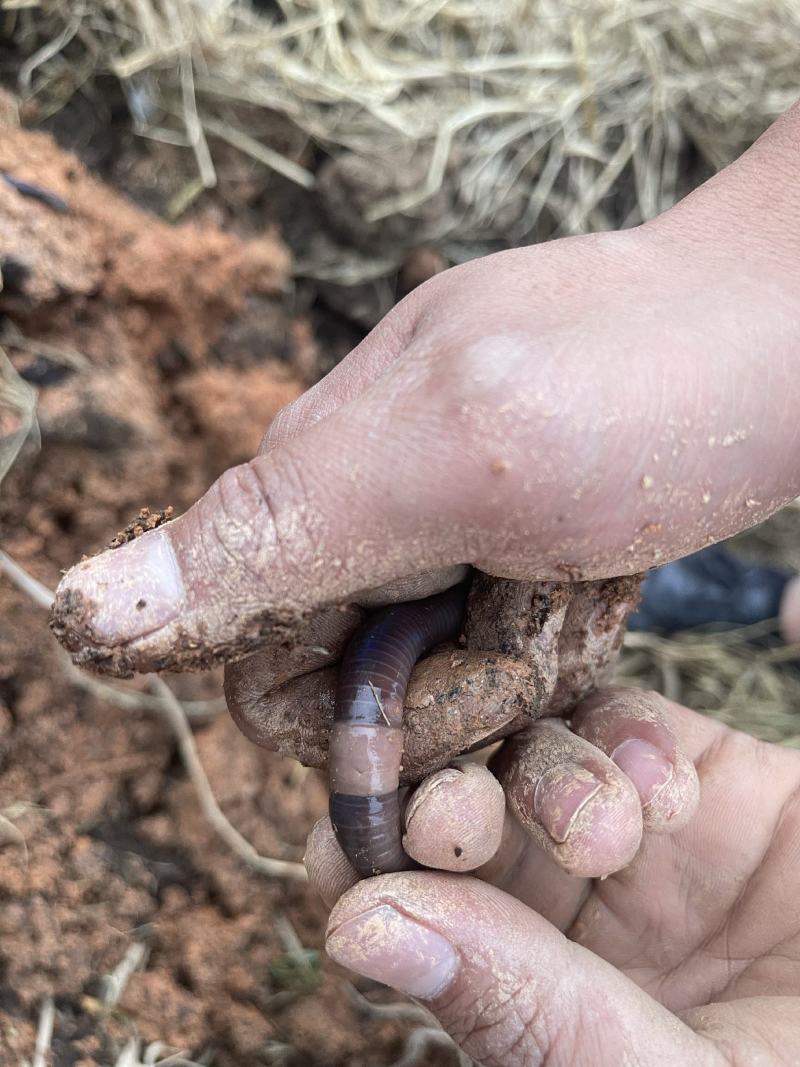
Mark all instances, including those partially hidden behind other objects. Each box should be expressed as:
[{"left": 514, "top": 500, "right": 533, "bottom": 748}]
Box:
[{"left": 52, "top": 362, "right": 462, "bottom": 673}]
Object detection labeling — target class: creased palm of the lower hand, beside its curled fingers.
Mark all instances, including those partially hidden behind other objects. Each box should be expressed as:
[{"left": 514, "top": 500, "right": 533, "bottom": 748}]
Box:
[{"left": 506, "top": 705, "right": 800, "bottom": 1013}]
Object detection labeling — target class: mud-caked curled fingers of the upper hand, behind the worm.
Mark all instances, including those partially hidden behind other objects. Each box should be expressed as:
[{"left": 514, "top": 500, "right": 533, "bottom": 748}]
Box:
[{"left": 220, "top": 573, "right": 639, "bottom": 784}]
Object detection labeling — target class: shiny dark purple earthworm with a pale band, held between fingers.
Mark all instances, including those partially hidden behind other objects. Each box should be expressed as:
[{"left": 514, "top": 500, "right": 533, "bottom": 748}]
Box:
[{"left": 329, "top": 583, "right": 468, "bottom": 878}]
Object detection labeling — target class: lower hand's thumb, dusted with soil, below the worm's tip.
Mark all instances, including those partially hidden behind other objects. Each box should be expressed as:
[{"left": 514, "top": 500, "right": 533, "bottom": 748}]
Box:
[{"left": 326, "top": 873, "right": 719, "bottom": 1067}]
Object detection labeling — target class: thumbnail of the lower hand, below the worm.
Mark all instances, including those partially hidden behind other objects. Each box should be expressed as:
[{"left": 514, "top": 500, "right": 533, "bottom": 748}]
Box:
[{"left": 325, "top": 904, "right": 459, "bottom": 1000}]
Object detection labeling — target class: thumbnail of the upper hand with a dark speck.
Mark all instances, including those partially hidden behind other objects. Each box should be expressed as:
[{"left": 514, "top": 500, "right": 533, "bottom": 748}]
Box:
[{"left": 58, "top": 530, "right": 185, "bottom": 644}]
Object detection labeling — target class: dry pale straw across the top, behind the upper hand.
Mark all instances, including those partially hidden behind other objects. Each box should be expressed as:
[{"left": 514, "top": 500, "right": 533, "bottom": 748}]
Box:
[{"left": 9, "top": 0, "right": 800, "bottom": 284}]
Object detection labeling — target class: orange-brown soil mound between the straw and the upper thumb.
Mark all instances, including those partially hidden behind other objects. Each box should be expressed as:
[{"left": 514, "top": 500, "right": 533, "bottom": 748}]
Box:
[{"left": 0, "top": 122, "right": 315, "bottom": 568}]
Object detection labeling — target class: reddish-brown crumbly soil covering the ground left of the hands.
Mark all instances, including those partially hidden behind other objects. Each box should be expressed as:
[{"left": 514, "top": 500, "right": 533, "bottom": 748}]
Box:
[{"left": 0, "top": 112, "right": 455, "bottom": 1067}]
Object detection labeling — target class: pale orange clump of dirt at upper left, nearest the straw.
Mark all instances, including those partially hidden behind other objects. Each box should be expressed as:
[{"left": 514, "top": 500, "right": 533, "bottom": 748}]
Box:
[{"left": 0, "top": 123, "right": 289, "bottom": 359}]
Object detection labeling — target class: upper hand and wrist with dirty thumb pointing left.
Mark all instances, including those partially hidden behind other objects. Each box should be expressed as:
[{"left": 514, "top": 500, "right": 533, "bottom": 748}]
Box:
[{"left": 50, "top": 121, "right": 800, "bottom": 681}]
